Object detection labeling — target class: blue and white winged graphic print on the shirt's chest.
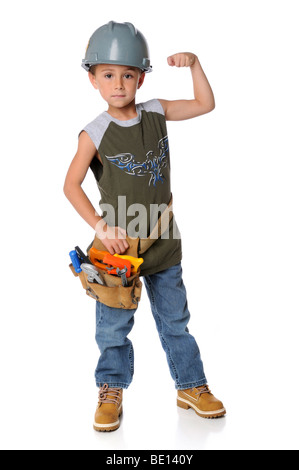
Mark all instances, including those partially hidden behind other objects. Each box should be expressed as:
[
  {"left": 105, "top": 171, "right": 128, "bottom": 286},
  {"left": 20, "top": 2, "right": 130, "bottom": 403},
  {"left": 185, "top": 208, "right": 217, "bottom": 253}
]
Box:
[{"left": 105, "top": 136, "right": 169, "bottom": 186}]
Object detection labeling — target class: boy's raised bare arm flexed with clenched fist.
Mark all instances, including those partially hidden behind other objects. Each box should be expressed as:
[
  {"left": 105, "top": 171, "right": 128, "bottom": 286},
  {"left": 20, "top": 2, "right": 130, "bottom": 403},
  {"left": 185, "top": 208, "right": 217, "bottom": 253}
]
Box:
[{"left": 160, "top": 52, "right": 215, "bottom": 121}]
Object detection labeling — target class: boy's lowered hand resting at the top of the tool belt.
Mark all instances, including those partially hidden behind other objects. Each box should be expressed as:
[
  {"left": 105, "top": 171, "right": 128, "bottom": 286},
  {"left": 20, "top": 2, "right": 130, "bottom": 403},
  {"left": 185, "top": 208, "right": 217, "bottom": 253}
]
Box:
[{"left": 96, "top": 219, "right": 129, "bottom": 255}]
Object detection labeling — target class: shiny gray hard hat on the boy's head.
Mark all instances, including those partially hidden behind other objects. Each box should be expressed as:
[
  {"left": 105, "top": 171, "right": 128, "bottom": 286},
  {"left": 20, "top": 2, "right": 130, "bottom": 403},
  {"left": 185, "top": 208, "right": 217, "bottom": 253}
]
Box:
[{"left": 82, "top": 21, "right": 152, "bottom": 72}]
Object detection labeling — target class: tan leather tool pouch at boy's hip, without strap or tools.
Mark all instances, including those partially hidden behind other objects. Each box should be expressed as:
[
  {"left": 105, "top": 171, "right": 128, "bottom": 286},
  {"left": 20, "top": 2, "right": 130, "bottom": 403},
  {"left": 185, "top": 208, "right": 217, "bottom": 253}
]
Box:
[{"left": 70, "top": 236, "right": 142, "bottom": 310}]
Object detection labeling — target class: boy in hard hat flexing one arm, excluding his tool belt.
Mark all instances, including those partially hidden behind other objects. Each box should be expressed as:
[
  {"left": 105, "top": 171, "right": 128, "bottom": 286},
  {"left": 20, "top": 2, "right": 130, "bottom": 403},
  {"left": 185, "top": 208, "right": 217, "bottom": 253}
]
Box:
[{"left": 64, "top": 21, "right": 226, "bottom": 431}]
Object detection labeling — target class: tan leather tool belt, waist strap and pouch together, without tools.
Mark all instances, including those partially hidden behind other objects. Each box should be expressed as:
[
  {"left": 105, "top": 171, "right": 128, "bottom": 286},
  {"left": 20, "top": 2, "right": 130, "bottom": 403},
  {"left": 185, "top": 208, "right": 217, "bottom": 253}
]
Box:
[{"left": 70, "top": 194, "right": 173, "bottom": 310}]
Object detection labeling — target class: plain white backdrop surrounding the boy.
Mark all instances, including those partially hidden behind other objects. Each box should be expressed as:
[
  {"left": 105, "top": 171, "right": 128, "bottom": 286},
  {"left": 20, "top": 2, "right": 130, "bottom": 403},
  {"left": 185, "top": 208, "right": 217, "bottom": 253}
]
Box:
[{"left": 0, "top": 0, "right": 299, "bottom": 450}]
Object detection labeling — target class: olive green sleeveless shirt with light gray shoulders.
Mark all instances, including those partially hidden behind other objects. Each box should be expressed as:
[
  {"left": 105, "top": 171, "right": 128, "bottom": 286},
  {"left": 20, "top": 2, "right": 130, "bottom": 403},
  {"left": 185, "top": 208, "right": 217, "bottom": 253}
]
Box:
[{"left": 83, "top": 100, "right": 182, "bottom": 276}]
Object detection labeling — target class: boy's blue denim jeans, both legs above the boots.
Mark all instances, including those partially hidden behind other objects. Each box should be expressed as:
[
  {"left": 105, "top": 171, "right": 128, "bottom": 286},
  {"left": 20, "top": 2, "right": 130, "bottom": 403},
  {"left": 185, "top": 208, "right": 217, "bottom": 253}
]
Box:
[{"left": 95, "top": 263, "right": 207, "bottom": 390}]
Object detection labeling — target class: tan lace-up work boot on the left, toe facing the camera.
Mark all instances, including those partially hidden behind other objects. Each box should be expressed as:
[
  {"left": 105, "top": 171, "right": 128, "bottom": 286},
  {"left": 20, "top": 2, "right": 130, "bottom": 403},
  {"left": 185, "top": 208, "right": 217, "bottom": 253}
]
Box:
[{"left": 93, "top": 384, "right": 123, "bottom": 431}]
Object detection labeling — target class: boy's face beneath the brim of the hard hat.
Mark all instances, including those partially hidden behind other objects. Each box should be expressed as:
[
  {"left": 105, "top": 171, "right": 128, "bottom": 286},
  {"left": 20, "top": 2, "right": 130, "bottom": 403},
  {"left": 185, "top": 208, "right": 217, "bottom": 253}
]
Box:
[{"left": 89, "top": 64, "right": 145, "bottom": 108}]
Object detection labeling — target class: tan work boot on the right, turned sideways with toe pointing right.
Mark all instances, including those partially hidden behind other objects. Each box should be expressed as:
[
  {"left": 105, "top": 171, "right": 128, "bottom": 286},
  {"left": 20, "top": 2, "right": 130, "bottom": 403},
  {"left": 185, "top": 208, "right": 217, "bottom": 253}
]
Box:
[{"left": 177, "top": 385, "right": 226, "bottom": 418}]
